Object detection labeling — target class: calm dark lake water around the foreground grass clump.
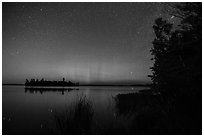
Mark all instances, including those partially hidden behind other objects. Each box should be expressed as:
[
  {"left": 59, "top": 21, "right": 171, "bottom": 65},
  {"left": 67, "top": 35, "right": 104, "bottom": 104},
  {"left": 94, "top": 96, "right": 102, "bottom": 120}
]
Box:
[{"left": 2, "top": 86, "right": 147, "bottom": 134}]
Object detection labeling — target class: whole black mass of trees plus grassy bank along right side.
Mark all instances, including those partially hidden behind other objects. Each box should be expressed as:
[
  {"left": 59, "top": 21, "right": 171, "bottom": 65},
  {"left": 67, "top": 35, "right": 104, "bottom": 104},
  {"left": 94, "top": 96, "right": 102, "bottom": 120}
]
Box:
[{"left": 116, "top": 2, "right": 202, "bottom": 135}]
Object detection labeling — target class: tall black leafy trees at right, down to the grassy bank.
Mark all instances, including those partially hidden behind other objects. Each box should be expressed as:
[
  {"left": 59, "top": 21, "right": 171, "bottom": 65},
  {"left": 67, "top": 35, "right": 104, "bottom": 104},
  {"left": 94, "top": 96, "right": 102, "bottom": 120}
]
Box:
[{"left": 150, "top": 3, "right": 202, "bottom": 95}]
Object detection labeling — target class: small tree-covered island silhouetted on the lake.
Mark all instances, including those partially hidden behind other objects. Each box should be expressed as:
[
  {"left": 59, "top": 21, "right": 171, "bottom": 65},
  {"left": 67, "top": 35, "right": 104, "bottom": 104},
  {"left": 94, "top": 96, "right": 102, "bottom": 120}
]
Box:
[{"left": 25, "top": 78, "right": 79, "bottom": 87}]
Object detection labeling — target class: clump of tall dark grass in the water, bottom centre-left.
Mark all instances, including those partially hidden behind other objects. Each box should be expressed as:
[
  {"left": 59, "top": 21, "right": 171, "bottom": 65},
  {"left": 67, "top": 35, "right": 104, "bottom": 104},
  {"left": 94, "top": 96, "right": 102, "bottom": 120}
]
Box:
[{"left": 50, "top": 96, "right": 94, "bottom": 135}]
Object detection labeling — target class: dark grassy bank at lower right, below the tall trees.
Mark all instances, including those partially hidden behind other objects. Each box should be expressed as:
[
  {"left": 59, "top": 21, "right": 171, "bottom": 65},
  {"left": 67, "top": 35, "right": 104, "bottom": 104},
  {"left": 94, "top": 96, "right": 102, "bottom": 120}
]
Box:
[{"left": 116, "top": 90, "right": 202, "bottom": 135}]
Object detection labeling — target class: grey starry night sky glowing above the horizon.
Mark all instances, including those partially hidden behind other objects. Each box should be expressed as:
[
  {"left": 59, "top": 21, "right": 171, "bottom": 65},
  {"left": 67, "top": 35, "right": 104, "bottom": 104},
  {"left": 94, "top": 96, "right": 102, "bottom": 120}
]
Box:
[{"left": 2, "top": 2, "right": 173, "bottom": 84}]
